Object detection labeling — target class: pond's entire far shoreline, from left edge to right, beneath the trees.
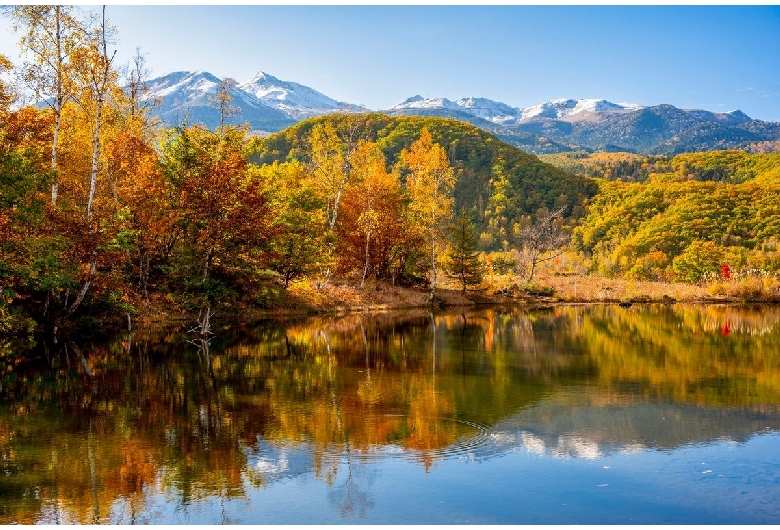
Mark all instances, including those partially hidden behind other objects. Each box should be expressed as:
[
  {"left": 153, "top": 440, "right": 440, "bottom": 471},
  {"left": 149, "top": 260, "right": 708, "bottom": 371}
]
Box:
[{"left": 0, "top": 275, "right": 780, "bottom": 337}]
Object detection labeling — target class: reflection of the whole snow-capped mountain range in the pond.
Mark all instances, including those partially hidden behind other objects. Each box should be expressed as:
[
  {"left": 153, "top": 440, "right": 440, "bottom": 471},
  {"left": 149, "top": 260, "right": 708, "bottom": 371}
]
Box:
[{"left": 242, "top": 398, "right": 780, "bottom": 474}]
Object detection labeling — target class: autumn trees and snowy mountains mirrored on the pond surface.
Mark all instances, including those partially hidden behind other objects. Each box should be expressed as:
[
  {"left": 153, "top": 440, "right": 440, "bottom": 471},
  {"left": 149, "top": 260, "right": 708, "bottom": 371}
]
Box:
[{"left": 0, "top": 306, "right": 780, "bottom": 523}]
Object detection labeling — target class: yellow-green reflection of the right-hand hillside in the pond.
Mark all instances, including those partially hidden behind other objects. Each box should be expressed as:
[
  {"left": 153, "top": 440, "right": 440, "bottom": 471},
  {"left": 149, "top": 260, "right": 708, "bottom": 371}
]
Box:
[{"left": 556, "top": 306, "right": 780, "bottom": 407}]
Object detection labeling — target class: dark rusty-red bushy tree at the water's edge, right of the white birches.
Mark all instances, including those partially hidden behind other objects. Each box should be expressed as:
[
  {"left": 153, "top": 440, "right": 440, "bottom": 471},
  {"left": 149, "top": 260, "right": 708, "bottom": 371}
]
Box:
[{"left": 160, "top": 126, "right": 271, "bottom": 309}]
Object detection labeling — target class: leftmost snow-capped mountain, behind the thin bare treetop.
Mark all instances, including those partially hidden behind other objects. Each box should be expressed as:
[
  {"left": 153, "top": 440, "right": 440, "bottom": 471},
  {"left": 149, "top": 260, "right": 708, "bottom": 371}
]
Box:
[{"left": 145, "top": 71, "right": 294, "bottom": 130}]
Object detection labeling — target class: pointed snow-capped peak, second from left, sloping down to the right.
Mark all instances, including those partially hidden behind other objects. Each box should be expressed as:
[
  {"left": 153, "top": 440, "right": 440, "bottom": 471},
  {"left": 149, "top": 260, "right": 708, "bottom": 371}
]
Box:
[{"left": 238, "top": 72, "right": 367, "bottom": 120}]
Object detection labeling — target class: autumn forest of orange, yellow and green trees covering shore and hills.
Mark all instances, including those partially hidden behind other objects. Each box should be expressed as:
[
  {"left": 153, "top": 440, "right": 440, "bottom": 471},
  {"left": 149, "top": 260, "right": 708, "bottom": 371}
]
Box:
[{"left": 0, "top": 6, "right": 780, "bottom": 333}]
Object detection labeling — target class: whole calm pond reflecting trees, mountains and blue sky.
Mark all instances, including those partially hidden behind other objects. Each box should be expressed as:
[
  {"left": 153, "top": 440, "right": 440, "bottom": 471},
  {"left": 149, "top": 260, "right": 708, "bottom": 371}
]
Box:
[{"left": 0, "top": 305, "right": 780, "bottom": 524}]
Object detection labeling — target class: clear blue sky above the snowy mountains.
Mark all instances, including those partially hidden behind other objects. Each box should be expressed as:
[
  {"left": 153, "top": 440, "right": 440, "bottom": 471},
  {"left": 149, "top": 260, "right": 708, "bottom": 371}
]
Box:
[{"left": 0, "top": 5, "right": 780, "bottom": 121}]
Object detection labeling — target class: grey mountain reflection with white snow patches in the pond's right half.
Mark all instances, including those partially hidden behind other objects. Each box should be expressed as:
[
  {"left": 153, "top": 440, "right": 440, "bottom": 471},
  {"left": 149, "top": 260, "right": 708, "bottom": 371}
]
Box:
[{"left": 464, "top": 400, "right": 780, "bottom": 459}]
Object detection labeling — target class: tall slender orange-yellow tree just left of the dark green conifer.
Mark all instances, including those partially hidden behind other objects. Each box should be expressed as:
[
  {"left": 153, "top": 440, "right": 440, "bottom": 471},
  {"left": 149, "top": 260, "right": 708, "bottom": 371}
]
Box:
[{"left": 400, "top": 128, "right": 455, "bottom": 301}]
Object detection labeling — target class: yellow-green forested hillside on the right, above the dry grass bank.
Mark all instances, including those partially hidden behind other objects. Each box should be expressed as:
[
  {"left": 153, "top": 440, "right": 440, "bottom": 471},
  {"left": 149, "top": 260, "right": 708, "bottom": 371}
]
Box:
[{"left": 543, "top": 151, "right": 780, "bottom": 282}]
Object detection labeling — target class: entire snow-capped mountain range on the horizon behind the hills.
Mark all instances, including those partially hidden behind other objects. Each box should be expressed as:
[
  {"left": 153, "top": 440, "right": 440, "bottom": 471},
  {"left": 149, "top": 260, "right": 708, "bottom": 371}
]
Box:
[{"left": 142, "top": 70, "right": 780, "bottom": 154}]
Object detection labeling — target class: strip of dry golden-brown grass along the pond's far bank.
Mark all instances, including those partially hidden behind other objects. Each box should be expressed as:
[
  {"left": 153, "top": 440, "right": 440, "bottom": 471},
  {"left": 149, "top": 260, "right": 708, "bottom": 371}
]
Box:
[{"left": 131, "top": 273, "right": 780, "bottom": 328}]
